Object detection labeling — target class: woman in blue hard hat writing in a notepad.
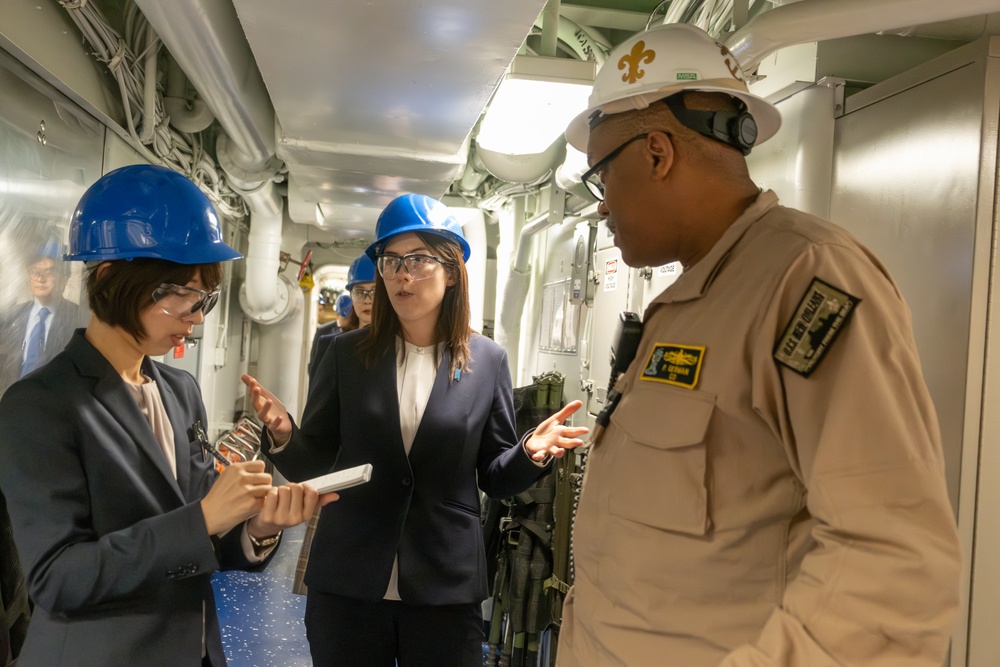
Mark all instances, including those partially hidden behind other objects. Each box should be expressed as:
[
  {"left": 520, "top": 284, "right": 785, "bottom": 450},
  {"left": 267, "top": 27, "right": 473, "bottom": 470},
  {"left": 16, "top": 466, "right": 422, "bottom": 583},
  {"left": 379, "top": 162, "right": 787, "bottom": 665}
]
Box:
[{"left": 0, "top": 166, "right": 333, "bottom": 667}]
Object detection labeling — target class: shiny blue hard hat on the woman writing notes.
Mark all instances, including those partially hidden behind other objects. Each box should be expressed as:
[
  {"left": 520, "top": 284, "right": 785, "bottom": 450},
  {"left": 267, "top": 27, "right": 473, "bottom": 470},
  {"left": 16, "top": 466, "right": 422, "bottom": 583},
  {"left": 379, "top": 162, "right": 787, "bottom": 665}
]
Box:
[{"left": 63, "top": 165, "right": 243, "bottom": 264}]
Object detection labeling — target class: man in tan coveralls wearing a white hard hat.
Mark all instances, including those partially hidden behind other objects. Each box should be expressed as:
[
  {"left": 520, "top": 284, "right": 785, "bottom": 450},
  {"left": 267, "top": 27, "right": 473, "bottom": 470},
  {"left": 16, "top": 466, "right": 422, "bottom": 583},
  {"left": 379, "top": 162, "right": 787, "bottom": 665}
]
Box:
[{"left": 558, "top": 25, "right": 960, "bottom": 667}]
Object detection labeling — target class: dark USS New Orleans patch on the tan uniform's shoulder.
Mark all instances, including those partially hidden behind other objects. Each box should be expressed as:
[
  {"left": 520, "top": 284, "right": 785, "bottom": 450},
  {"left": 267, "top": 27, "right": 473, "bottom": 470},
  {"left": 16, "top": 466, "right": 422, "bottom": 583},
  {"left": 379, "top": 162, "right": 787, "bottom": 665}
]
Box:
[{"left": 774, "top": 278, "right": 861, "bottom": 377}]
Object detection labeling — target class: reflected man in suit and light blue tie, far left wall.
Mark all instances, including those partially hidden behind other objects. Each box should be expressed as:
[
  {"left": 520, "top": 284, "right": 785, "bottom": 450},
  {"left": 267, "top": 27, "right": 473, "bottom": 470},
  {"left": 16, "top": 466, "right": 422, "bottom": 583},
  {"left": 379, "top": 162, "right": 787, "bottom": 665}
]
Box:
[{"left": 0, "top": 241, "right": 79, "bottom": 394}]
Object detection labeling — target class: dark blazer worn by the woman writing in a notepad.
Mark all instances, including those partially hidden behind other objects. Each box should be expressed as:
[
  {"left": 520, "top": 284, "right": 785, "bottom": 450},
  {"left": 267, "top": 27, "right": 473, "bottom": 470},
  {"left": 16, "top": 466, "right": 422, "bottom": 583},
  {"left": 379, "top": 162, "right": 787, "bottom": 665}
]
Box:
[{"left": 0, "top": 329, "right": 264, "bottom": 667}]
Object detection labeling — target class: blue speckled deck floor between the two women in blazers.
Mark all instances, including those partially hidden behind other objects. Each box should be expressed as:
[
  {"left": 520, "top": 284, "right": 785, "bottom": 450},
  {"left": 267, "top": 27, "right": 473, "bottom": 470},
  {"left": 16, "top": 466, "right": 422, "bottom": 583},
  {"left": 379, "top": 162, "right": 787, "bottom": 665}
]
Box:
[{"left": 212, "top": 525, "right": 312, "bottom": 667}]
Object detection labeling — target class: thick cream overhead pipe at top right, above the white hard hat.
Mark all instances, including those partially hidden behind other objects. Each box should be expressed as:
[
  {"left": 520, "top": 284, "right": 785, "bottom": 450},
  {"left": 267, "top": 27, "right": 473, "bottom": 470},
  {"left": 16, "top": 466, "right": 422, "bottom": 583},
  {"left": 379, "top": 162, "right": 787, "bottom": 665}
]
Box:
[{"left": 725, "top": 0, "right": 1000, "bottom": 71}]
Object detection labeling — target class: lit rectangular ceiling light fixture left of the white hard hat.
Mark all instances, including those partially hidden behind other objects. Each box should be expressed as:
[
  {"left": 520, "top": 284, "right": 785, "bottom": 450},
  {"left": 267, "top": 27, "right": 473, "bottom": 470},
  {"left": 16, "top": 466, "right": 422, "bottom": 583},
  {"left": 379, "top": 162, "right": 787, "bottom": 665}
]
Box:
[{"left": 476, "top": 56, "right": 597, "bottom": 155}]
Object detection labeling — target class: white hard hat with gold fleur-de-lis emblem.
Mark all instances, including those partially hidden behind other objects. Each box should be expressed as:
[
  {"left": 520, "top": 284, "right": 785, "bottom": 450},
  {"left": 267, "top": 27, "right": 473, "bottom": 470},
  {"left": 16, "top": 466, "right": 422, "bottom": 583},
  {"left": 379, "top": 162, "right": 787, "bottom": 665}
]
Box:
[{"left": 566, "top": 23, "right": 781, "bottom": 152}]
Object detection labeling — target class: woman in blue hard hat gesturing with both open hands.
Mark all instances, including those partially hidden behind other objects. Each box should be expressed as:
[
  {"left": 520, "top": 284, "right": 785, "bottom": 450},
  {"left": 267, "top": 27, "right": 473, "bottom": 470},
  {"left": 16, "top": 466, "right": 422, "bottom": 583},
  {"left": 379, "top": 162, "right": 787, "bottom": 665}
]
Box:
[{"left": 244, "top": 195, "right": 587, "bottom": 667}]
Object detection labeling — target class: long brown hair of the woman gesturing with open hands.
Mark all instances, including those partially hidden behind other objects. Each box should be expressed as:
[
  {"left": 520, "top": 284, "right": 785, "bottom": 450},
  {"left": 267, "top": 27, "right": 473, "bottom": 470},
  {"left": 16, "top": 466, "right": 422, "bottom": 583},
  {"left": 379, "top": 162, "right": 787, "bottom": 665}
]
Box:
[{"left": 358, "top": 232, "right": 472, "bottom": 378}]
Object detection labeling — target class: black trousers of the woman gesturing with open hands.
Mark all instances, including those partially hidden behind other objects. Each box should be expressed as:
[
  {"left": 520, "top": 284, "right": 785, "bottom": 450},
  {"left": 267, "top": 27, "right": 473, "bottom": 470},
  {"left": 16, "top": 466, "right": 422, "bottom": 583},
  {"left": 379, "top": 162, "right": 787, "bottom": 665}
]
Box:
[{"left": 305, "top": 589, "right": 483, "bottom": 667}]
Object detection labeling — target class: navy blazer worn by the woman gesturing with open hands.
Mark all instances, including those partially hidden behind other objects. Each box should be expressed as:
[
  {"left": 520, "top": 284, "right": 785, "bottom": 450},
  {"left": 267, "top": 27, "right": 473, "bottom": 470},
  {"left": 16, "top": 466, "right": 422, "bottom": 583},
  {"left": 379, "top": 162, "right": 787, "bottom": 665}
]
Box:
[{"left": 265, "top": 327, "right": 544, "bottom": 605}]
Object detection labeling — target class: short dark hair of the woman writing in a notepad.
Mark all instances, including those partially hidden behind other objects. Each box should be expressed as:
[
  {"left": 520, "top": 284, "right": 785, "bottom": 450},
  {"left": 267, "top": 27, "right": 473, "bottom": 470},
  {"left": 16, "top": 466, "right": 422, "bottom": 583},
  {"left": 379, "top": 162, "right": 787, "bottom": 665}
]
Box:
[{"left": 87, "top": 257, "right": 222, "bottom": 341}]
